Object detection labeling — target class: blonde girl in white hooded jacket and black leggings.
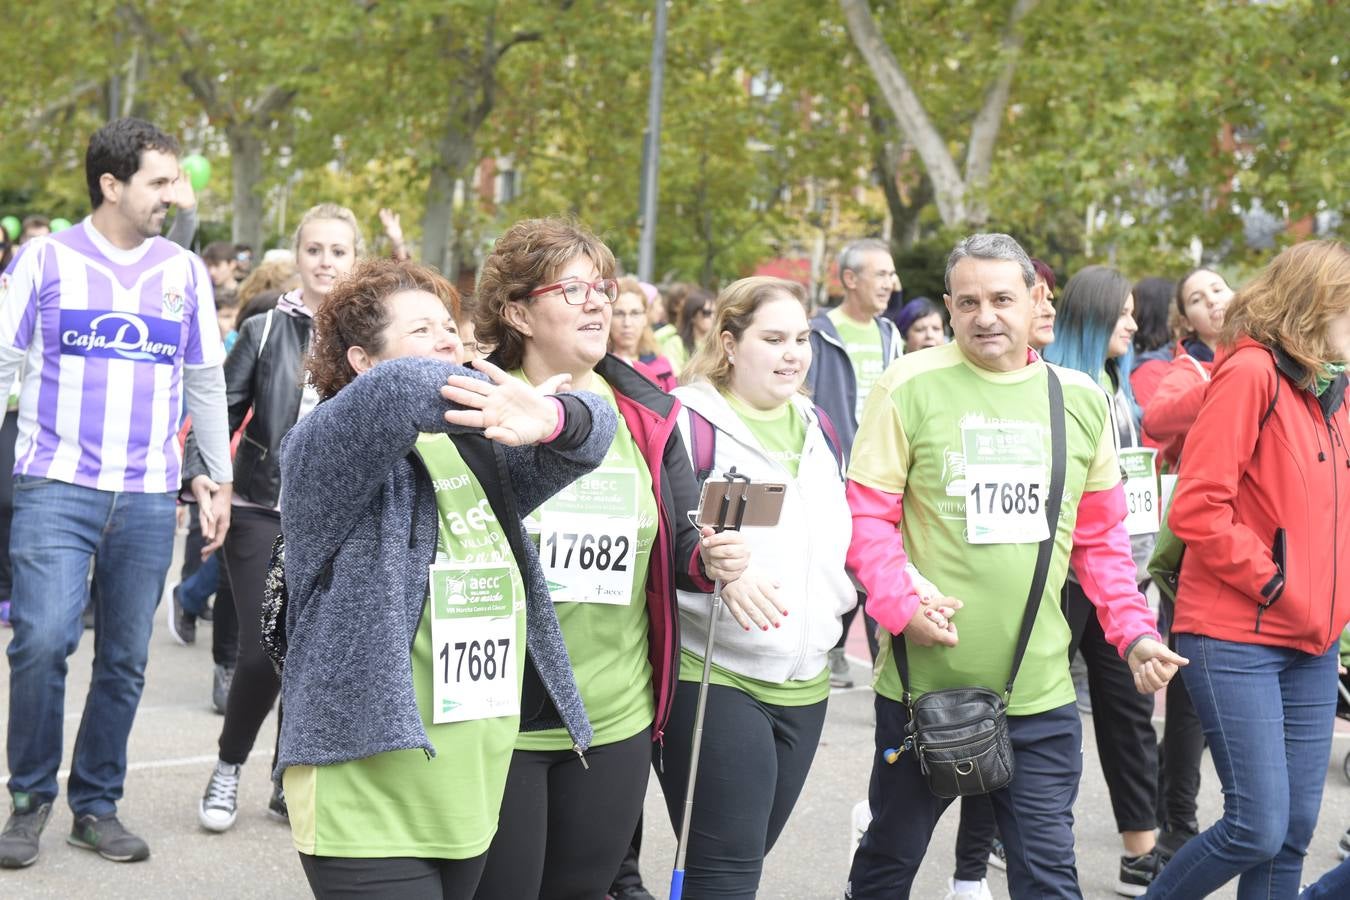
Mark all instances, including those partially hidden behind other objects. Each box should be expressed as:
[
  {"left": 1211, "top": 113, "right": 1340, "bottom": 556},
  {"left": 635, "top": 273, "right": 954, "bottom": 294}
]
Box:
[{"left": 657, "top": 278, "right": 857, "bottom": 899}]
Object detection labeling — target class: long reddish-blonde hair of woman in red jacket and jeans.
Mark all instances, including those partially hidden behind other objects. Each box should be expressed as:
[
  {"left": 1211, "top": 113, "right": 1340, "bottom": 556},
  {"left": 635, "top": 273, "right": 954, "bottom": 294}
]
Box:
[{"left": 1222, "top": 240, "right": 1350, "bottom": 387}]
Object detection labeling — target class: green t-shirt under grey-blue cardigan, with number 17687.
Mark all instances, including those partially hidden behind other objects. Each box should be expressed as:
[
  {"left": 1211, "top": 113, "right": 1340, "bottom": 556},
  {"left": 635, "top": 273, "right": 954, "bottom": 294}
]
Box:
[{"left": 284, "top": 434, "right": 525, "bottom": 860}]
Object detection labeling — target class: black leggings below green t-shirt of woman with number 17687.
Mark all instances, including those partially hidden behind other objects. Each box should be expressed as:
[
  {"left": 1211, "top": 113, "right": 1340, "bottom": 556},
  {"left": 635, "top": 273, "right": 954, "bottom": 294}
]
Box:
[{"left": 300, "top": 853, "right": 487, "bottom": 900}]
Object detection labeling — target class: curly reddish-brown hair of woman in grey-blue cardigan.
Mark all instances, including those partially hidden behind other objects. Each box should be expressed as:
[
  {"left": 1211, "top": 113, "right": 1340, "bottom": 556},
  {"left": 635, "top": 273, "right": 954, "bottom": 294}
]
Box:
[{"left": 306, "top": 258, "right": 459, "bottom": 399}]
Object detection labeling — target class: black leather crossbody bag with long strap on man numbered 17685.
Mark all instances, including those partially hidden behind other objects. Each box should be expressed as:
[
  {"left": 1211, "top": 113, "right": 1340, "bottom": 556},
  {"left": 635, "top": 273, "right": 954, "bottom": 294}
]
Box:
[{"left": 894, "top": 366, "right": 1067, "bottom": 797}]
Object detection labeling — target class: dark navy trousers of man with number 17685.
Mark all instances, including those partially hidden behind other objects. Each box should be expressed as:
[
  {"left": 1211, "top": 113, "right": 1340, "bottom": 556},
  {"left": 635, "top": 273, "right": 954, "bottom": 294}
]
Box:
[{"left": 844, "top": 695, "right": 1083, "bottom": 900}]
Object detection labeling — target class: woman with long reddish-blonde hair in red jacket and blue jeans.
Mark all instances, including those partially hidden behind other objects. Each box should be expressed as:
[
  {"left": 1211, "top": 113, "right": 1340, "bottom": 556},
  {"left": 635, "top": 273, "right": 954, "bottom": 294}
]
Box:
[{"left": 1148, "top": 240, "right": 1350, "bottom": 900}]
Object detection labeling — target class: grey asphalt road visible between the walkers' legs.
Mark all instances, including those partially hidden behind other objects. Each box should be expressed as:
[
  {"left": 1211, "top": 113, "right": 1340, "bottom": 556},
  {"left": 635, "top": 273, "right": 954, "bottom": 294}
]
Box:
[{"left": 0, "top": 534, "right": 1350, "bottom": 900}]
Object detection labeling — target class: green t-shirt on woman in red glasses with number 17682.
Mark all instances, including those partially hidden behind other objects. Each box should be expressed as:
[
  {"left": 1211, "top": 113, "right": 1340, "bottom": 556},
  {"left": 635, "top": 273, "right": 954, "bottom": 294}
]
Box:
[{"left": 516, "top": 375, "right": 657, "bottom": 750}]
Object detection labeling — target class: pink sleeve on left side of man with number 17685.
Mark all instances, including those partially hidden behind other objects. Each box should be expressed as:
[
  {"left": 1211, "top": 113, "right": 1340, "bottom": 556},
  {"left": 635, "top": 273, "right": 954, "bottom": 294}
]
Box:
[{"left": 846, "top": 480, "right": 919, "bottom": 634}]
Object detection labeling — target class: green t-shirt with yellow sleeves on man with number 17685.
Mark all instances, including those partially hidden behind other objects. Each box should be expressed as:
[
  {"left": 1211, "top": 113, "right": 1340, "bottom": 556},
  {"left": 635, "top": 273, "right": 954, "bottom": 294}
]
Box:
[{"left": 849, "top": 343, "right": 1121, "bottom": 715}]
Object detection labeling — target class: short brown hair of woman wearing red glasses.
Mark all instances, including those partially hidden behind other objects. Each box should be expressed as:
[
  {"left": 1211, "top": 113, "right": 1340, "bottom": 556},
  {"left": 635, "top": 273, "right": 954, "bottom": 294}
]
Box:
[{"left": 474, "top": 219, "right": 614, "bottom": 370}]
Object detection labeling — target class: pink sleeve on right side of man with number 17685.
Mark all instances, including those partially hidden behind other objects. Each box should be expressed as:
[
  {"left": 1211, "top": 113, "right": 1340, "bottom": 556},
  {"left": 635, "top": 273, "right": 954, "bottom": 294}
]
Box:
[{"left": 1069, "top": 484, "right": 1161, "bottom": 657}]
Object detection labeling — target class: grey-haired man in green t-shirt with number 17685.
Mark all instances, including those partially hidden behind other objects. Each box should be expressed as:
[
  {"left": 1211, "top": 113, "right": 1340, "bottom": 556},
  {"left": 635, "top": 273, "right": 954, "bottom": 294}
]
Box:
[{"left": 846, "top": 235, "right": 1185, "bottom": 900}]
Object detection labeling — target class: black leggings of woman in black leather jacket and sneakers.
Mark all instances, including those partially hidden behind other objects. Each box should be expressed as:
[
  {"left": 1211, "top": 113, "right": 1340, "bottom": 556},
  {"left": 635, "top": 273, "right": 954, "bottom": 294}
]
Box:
[{"left": 220, "top": 506, "right": 282, "bottom": 765}]
